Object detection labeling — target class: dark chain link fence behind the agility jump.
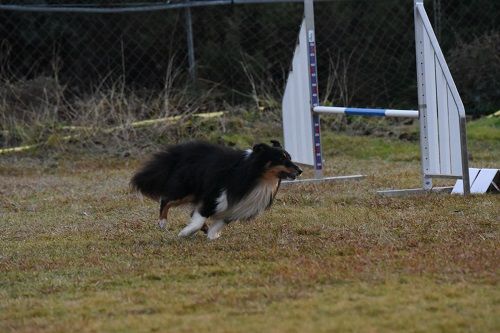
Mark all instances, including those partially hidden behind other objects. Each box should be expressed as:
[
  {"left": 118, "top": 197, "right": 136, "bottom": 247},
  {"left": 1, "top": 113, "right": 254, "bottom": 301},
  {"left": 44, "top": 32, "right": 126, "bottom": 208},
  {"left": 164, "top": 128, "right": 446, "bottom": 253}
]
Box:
[{"left": 0, "top": 0, "right": 500, "bottom": 113}]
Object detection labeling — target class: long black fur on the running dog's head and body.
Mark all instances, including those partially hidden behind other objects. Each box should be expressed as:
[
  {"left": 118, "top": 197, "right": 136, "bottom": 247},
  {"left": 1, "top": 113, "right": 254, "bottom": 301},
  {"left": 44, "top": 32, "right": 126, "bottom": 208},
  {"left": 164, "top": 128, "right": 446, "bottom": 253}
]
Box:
[{"left": 131, "top": 141, "right": 301, "bottom": 222}]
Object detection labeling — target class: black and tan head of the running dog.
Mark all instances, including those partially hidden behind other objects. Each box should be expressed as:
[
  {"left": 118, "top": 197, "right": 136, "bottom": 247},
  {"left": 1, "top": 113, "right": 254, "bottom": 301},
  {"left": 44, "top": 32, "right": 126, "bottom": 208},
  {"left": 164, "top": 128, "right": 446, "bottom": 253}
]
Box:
[{"left": 252, "top": 140, "right": 302, "bottom": 179}]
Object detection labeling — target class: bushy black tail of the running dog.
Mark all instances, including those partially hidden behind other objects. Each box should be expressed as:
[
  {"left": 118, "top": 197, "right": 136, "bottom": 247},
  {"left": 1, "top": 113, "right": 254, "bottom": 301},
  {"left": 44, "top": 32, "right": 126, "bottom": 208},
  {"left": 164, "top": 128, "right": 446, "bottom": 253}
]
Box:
[{"left": 130, "top": 151, "right": 175, "bottom": 200}]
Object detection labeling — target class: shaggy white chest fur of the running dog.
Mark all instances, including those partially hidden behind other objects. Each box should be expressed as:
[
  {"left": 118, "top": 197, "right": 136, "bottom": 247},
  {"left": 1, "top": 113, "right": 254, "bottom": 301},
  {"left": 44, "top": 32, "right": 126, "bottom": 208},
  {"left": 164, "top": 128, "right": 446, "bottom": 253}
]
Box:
[{"left": 214, "top": 182, "right": 278, "bottom": 221}]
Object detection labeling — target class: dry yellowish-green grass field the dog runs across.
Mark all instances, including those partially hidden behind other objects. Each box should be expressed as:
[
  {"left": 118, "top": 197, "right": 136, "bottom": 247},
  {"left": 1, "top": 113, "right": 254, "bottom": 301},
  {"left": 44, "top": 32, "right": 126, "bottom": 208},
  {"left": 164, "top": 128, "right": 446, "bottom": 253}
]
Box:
[{"left": 0, "top": 118, "right": 500, "bottom": 332}]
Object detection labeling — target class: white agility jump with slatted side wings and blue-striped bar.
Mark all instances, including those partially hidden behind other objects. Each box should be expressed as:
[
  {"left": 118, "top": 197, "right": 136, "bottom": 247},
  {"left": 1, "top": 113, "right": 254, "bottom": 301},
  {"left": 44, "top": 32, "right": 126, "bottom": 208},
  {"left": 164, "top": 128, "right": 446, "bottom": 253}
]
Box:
[{"left": 282, "top": 0, "right": 470, "bottom": 195}]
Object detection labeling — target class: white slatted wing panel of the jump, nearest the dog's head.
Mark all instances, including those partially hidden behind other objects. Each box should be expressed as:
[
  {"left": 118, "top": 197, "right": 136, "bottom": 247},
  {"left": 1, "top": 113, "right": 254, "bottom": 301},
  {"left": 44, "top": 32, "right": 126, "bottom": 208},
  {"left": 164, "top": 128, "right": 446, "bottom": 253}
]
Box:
[{"left": 282, "top": 22, "right": 314, "bottom": 165}]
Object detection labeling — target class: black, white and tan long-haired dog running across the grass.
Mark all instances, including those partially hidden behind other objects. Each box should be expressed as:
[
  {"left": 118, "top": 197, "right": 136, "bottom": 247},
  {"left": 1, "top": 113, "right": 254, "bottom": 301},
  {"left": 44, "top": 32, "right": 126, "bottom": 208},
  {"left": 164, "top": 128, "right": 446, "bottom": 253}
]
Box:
[{"left": 131, "top": 140, "right": 302, "bottom": 240}]
